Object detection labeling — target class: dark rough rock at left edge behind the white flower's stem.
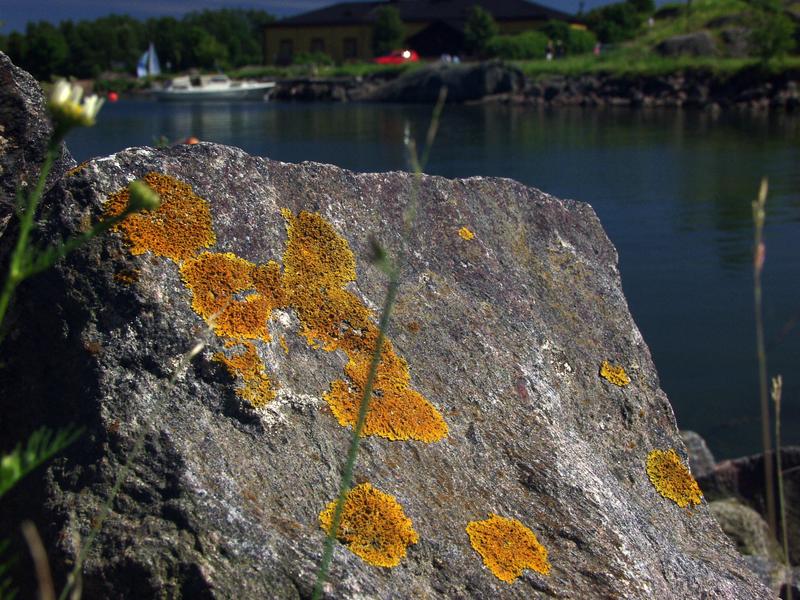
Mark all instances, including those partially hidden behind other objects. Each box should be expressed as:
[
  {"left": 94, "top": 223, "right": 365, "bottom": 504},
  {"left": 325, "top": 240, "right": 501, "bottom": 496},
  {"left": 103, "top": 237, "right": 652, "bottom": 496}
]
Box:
[{"left": 0, "top": 52, "right": 75, "bottom": 237}]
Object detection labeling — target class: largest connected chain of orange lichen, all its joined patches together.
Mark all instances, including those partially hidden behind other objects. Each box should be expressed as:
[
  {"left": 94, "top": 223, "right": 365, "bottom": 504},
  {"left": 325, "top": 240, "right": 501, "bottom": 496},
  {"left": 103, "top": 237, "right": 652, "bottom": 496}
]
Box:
[{"left": 106, "top": 173, "right": 447, "bottom": 442}]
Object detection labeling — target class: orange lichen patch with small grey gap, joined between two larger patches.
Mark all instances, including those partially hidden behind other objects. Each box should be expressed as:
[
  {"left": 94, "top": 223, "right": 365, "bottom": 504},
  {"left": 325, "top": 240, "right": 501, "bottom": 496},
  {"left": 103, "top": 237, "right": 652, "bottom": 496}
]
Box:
[{"left": 181, "top": 252, "right": 284, "bottom": 341}]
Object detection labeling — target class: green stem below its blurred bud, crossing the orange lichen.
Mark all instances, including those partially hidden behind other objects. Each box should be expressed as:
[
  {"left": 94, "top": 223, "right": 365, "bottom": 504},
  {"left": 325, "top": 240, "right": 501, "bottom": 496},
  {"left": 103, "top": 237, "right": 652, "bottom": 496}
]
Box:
[{"left": 312, "top": 268, "right": 400, "bottom": 600}]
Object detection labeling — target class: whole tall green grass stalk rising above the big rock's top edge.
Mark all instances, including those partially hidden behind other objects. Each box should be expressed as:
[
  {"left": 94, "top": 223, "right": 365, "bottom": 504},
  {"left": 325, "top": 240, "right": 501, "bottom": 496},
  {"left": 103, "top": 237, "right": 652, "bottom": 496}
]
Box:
[{"left": 312, "top": 87, "right": 447, "bottom": 600}]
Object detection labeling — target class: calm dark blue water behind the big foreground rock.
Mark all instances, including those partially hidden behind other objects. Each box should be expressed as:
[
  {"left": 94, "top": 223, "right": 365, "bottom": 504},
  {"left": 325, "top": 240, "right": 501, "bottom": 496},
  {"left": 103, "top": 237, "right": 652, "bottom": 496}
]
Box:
[{"left": 68, "top": 101, "right": 800, "bottom": 457}]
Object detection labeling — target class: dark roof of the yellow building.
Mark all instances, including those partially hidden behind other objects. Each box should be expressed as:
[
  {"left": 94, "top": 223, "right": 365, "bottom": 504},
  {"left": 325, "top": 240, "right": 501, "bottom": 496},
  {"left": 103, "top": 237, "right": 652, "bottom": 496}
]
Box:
[{"left": 267, "top": 0, "right": 575, "bottom": 27}]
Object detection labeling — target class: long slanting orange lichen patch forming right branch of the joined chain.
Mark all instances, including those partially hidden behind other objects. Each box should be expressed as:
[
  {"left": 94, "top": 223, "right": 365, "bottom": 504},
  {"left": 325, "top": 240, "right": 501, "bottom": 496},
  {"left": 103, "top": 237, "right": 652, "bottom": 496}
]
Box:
[{"left": 283, "top": 210, "right": 447, "bottom": 442}]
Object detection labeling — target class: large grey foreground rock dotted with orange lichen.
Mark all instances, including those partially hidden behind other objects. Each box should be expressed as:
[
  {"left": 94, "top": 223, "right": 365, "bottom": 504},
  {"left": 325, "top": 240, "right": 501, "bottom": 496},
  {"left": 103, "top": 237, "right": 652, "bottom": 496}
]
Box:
[{"left": 0, "top": 52, "right": 770, "bottom": 600}]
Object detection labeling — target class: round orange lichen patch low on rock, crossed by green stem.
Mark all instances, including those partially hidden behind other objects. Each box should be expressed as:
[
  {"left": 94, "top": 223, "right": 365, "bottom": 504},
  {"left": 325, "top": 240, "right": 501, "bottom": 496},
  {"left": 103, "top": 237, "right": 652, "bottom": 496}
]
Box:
[{"left": 319, "top": 483, "right": 419, "bottom": 567}]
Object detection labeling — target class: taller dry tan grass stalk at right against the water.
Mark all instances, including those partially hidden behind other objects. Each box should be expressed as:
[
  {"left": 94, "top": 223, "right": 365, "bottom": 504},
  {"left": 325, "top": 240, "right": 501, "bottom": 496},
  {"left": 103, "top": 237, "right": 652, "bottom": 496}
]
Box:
[{"left": 752, "top": 178, "right": 777, "bottom": 537}]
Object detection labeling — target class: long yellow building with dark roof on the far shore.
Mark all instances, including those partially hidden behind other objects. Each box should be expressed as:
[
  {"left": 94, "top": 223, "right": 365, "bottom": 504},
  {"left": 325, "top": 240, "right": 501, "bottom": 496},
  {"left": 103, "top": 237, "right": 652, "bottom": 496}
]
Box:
[{"left": 264, "top": 0, "right": 579, "bottom": 64}]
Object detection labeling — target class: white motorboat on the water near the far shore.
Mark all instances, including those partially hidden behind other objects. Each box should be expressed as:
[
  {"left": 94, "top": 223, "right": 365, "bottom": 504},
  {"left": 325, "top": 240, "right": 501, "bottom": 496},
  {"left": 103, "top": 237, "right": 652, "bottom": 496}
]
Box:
[{"left": 152, "top": 73, "right": 275, "bottom": 101}]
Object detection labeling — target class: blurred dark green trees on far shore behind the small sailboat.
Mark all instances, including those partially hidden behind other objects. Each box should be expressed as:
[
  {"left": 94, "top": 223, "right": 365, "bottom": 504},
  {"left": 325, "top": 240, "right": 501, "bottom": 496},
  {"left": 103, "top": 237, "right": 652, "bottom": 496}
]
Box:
[{"left": 0, "top": 9, "right": 274, "bottom": 80}]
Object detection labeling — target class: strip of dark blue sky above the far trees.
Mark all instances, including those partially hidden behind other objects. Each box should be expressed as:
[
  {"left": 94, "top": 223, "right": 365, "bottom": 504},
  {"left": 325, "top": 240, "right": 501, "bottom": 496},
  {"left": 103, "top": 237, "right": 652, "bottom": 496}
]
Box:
[{"left": 0, "top": 0, "right": 648, "bottom": 34}]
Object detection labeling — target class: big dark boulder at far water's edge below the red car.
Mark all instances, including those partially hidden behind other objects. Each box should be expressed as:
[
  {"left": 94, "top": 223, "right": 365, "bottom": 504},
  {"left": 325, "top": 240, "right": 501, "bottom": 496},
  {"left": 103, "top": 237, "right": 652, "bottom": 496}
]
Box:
[{"left": 351, "top": 61, "right": 524, "bottom": 102}]
